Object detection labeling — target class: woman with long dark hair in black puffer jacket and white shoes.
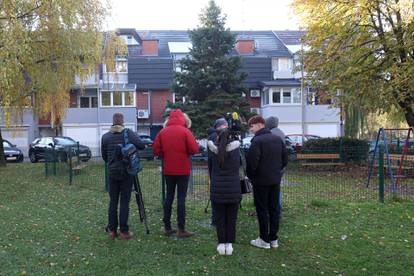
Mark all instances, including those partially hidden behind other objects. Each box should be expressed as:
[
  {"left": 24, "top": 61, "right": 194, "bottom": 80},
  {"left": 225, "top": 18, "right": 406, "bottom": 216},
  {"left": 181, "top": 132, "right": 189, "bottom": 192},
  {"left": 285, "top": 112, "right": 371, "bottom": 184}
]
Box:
[{"left": 208, "top": 129, "right": 241, "bottom": 255}]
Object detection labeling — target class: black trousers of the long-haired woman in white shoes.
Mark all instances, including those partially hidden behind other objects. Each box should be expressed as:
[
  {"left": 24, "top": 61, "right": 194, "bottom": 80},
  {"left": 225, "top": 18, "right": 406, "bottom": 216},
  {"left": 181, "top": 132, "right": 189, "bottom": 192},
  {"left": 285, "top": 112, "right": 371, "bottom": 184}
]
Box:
[{"left": 214, "top": 203, "right": 240, "bottom": 243}]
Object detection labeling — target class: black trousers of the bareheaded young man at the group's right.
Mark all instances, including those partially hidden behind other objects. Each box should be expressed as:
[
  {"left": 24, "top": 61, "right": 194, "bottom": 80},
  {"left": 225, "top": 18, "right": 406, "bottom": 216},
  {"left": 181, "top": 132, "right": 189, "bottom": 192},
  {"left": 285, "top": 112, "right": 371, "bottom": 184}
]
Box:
[{"left": 253, "top": 185, "right": 280, "bottom": 242}]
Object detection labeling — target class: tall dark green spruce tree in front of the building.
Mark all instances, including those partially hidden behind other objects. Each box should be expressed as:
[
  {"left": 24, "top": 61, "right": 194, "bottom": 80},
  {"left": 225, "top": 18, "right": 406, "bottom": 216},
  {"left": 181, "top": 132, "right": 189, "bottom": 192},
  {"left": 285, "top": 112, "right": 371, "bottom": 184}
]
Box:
[{"left": 173, "top": 1, "right": 249, "bottom": 137}]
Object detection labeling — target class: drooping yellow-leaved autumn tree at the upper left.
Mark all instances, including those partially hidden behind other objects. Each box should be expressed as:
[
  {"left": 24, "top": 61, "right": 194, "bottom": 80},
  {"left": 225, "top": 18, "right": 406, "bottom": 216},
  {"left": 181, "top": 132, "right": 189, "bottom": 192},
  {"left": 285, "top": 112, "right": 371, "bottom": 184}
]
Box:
[{"left": 0, "top": 0, "right": 126, "bottom": 164}]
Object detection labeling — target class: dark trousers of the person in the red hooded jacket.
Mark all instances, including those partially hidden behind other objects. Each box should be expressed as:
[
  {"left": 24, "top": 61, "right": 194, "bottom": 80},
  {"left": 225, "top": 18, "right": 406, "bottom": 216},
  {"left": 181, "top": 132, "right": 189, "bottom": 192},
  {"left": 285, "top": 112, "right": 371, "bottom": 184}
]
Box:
[{"left": 163, "top": 175, "right": 189, "bottom": 230}]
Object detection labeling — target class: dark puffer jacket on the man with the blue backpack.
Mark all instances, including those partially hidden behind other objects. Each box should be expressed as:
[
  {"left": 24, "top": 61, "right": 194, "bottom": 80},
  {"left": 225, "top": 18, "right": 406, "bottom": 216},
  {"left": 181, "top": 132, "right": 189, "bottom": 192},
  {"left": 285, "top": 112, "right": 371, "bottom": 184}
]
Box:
[{"left": 101, "top": 125, "right": 145, "bottom": 178}]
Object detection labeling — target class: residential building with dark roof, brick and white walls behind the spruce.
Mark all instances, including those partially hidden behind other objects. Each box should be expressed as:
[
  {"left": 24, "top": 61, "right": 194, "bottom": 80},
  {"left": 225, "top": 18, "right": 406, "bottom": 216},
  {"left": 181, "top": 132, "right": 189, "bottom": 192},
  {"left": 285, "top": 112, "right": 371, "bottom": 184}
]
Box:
[{"left": 0, "top": 29, "right": 340, "bottom": 158}]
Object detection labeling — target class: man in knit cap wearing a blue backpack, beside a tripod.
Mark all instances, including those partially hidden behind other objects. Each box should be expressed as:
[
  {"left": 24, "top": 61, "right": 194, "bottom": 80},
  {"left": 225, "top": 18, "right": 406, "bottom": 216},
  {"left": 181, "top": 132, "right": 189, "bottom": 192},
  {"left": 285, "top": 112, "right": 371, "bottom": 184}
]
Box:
[{"left": 101, "top": 113, "right": 145, "bottom": 240}]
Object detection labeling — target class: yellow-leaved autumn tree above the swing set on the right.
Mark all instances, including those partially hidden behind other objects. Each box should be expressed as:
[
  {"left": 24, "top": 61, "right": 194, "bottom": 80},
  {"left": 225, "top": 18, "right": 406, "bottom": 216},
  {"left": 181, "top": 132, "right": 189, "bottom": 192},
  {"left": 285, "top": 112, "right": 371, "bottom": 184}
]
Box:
[{"left": 293, "top": 0, "right": 414, "bottom": 126}]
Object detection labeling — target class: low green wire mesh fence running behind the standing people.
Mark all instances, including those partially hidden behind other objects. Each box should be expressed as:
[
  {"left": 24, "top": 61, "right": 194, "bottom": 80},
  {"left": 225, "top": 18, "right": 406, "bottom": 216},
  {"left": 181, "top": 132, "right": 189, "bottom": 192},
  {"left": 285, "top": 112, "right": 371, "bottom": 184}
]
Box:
[{"left": 45, "top": 148, "right": 414, "bottom": 206}]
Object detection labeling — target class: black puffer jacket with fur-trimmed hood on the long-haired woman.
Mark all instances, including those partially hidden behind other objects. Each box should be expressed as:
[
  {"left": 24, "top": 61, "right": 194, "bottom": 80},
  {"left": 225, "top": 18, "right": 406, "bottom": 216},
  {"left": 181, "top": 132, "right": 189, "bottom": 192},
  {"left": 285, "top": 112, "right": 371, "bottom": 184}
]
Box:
[{"left": 208, "top": 141, "right": 241, "bottom": 203}]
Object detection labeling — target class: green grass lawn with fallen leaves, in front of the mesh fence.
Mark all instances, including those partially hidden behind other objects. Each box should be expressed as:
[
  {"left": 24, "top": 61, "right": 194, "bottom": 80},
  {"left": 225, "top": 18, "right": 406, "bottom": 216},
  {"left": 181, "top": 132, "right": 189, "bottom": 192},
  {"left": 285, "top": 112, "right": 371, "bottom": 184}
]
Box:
[{"left": 0, "top": 164, "right": 414, "bottom": 275}]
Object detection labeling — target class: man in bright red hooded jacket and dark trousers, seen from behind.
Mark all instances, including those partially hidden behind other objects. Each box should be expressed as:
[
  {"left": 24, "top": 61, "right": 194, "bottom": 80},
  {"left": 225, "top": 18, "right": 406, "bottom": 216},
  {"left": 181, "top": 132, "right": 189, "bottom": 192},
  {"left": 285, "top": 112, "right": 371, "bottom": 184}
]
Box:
[{"left": 153, "top": 109, "right": 199, "bottom": 238}]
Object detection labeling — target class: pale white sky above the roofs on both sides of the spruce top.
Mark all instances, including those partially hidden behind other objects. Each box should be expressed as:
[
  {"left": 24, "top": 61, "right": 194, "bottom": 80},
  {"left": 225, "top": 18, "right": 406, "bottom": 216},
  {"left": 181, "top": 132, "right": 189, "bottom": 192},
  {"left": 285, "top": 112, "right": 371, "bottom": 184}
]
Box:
[{"left": 102, "top": 0, "right": 299, "bottom": 30}]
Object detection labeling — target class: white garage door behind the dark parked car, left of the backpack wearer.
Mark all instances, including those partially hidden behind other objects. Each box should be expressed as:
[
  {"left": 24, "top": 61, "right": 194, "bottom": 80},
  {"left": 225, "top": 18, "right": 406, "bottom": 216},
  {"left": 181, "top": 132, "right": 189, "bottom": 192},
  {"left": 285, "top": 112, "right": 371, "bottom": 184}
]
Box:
[{"left": 63, "top": 126, "right": 99, "bottom": 156}]
